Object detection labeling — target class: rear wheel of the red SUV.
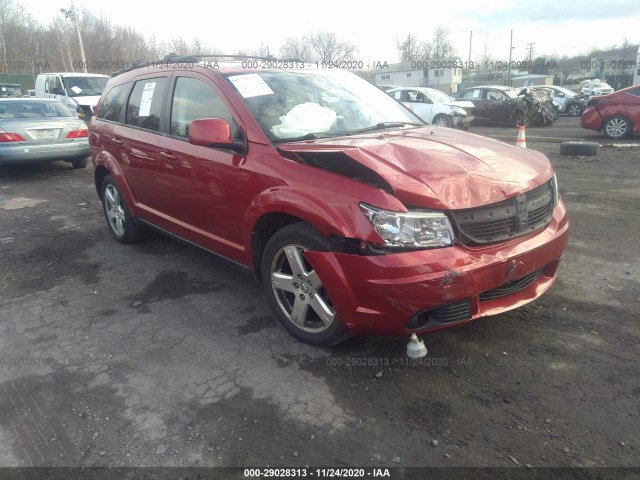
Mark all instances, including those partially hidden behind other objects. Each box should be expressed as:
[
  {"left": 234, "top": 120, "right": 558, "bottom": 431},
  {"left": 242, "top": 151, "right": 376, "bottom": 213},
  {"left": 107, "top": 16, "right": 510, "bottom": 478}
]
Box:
[{"left": 101, "top": 175, "right": 145, "bottom": 243}]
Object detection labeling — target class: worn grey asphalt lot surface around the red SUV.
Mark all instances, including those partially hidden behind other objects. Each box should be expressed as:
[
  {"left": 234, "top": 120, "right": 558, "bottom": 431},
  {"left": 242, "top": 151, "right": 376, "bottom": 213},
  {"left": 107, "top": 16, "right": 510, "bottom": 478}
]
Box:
[{"left": 0, "top": 117, "right": 640, "bottom": 467}]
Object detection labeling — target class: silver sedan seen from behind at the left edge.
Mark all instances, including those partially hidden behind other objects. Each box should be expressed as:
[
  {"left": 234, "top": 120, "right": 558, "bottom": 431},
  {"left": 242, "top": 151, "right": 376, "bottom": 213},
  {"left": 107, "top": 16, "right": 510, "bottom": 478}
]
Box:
[{"left": 0, "top": 98, "right": 90, "bottom": 168}]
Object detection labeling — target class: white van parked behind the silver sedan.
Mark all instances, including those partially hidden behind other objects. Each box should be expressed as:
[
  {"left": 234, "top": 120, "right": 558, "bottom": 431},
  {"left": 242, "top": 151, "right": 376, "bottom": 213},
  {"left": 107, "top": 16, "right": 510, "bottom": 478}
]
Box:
[{"left": 36, "top": 72, "right": 109, "bottom": 118}]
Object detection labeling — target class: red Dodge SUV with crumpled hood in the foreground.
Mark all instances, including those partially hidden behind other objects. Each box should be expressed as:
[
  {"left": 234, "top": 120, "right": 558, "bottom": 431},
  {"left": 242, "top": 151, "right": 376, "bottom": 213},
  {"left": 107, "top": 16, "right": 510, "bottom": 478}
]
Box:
[{"left": 90, "top": 58, "right": 569, "bottom": 345}]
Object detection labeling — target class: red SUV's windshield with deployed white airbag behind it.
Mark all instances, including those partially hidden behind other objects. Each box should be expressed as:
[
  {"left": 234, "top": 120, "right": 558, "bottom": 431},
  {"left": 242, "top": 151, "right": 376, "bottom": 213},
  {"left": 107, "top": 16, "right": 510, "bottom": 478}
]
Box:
[{"left": 226, "top": 70, "right": 424, "bottom": 141}]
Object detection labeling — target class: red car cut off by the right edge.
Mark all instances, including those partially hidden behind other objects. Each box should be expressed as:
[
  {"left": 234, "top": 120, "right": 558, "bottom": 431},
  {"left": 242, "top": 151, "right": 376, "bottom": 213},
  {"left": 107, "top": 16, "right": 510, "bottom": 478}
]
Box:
[{"left": 580, "top": 85, "right": 640, "bottom": 138}]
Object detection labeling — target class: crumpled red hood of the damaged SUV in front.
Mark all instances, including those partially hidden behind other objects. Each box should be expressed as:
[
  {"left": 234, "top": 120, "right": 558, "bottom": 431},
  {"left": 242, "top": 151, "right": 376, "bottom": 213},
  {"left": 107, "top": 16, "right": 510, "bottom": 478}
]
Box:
[{"left": 278, "top": 126, "right": 553, "bottom": 209}]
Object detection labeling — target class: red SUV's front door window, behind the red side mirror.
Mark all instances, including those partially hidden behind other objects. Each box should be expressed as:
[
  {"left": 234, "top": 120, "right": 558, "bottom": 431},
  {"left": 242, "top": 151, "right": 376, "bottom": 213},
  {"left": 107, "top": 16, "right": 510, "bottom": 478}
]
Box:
[{"left": 171, "top": 77, "right": 238, "bottom": 138}]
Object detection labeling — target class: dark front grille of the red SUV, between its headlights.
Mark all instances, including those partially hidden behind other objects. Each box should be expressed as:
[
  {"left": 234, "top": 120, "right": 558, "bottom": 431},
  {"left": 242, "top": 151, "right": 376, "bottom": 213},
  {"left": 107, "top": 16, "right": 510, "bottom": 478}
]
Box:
[{"left": 452, "top": 179, "right": 557, "bottom": 245}]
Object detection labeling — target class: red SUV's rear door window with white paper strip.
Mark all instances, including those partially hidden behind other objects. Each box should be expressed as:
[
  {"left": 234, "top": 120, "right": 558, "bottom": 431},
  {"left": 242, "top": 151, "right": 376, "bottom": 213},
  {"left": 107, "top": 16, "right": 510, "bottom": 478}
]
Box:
[{"left": 125, "top": 77, "right": 169, "bottom": 131}]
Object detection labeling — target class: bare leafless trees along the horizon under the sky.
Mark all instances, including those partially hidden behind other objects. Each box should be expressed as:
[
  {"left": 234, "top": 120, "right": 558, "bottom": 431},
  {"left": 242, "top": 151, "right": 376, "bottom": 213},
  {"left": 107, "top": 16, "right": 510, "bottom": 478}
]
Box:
[{"left": 0, "top": 0, "right": 638, "bottom": 81}]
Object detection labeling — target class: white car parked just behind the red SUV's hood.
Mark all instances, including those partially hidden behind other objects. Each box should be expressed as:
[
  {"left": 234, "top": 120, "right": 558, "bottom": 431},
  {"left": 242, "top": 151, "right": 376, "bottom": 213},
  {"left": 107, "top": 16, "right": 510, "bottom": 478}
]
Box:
[{"left": 387, "top": 87, "right": 475, "bottom": 130}]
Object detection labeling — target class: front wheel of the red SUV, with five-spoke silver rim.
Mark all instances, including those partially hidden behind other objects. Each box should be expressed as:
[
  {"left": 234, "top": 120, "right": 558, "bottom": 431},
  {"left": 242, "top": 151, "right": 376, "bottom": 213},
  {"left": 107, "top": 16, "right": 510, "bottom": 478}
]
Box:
[{"left": 262, "top": 222, "right": 348, "bottom": 347}]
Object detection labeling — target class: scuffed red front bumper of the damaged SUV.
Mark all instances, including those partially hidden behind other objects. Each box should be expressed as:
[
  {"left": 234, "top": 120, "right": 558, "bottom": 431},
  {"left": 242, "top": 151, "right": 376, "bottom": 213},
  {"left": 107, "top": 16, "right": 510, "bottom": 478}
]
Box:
[{"left": 305, "top": 197, "right": 569, "bottom": 336}]
